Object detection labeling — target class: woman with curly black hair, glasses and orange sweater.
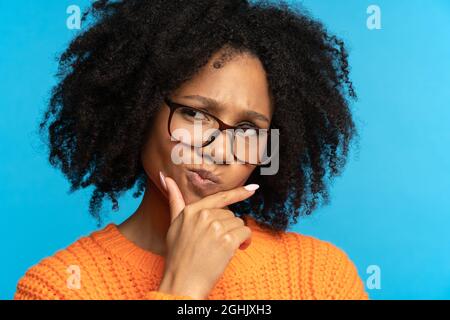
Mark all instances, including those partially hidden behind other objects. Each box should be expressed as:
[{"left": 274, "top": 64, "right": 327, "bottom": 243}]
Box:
[{"left": 15, "top": 0, "right": 368, "bottom": 299}]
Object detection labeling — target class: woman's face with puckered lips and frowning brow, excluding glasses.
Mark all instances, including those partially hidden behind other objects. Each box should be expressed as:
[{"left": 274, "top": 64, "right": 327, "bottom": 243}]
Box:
[{"left": 142, "top": 52, "right": 273, "bottom": 204}]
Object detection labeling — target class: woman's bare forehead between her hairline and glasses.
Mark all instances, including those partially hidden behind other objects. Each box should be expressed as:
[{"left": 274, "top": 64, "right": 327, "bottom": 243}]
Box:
[{"left": 172, "top": 53, "right": 272, "bottom": 119}]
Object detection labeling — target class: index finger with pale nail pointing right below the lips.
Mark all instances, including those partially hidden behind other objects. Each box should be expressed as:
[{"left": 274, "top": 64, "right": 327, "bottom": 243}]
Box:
[{"left": 191, "top": 184, "right": 259, "bottom": 210}]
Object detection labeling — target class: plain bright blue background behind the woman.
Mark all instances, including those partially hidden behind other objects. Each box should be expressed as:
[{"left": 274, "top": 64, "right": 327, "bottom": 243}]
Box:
[{"left": 0, "top": 0, "right": 450, "bottom": 299}]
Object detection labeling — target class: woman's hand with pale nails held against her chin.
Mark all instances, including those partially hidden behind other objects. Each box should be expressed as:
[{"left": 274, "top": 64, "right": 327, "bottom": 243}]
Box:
[{"left": 159, "top": 172, "right": 259, "bottom": 299}]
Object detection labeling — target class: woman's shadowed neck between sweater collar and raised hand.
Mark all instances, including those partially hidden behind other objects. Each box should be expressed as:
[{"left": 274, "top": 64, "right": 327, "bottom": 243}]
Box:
[{"left": 118, "top": 178, "right": 170, "bottom": 256}]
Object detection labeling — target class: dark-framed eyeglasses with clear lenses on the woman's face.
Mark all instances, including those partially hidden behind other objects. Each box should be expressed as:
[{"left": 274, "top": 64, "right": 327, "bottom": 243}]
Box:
[{"left": 164, "top": 97, "right": 270, "bottom": 165}]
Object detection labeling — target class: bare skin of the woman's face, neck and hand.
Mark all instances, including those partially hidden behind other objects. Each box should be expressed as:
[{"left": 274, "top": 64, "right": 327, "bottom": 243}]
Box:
[{"left": 119, "top": 51, "right": 273, "bottom": 299}]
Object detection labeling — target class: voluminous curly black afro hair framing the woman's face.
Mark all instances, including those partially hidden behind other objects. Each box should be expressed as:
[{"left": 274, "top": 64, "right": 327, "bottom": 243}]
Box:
[{"left": 39, "top": 0, "right": 357, "bottom": 232}]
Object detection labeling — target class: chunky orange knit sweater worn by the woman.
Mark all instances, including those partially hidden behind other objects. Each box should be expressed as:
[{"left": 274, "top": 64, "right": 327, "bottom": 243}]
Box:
[{"left": 14, "top": 216, "right": 368, "bottom": 300}]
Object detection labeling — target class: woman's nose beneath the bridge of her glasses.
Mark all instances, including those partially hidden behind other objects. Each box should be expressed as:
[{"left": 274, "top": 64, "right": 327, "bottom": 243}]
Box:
[{"left": 197, "top": 130, "right": 234, "bottom": 164}]
